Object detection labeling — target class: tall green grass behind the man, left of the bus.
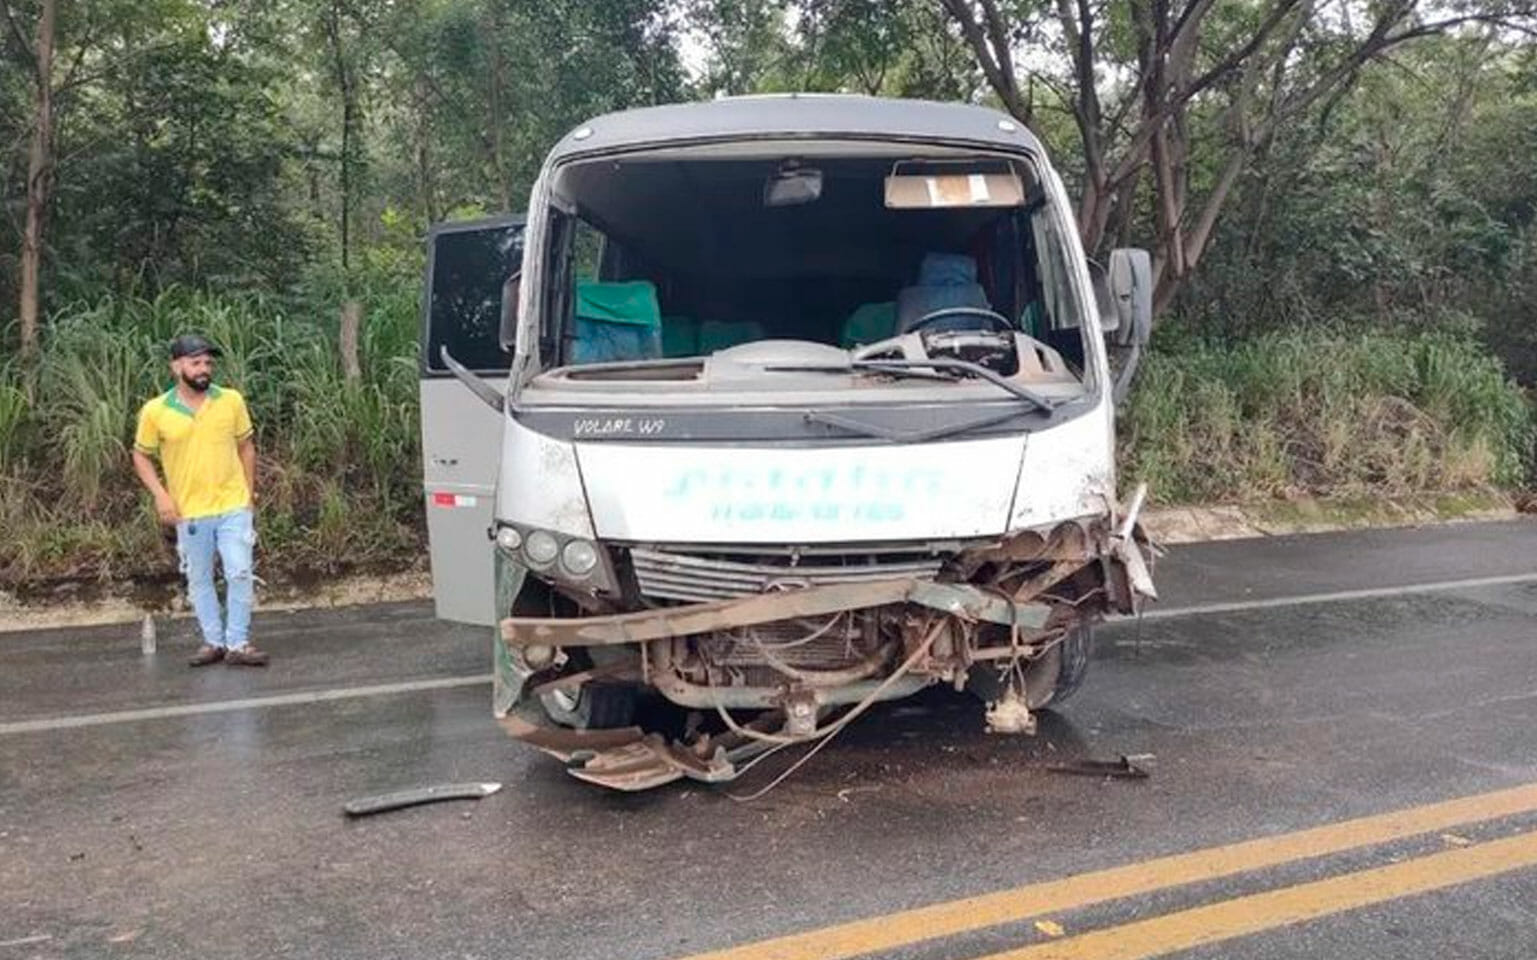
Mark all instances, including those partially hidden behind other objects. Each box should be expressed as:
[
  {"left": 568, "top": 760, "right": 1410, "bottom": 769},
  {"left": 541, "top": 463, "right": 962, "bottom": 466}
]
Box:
[{"left": 0, "top": 258, "right": 421, "bottom": 585}]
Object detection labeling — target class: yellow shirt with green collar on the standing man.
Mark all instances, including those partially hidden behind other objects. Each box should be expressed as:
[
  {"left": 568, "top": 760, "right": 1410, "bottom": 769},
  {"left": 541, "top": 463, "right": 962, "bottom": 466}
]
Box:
[{"left": 134, "top": 387, "right": 251, "bottom": 519}]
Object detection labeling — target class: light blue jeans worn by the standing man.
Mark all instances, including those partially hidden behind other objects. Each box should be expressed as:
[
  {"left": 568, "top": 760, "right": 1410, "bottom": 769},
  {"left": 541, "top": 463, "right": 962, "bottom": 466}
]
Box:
[{"left": 177, "top": 510, "right": 257, "bottom": 650}]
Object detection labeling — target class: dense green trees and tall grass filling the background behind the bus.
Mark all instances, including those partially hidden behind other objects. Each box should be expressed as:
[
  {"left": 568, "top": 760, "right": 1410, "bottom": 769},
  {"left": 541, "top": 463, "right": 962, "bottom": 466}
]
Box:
[{"left": 0, "top": 0, "right": 1537, "bottom": 582}]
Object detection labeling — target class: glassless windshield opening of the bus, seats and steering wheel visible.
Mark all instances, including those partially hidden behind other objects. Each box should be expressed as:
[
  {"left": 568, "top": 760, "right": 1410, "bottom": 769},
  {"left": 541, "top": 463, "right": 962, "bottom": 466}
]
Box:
[{"left": 525, "top": 143, "right": 1090, "bottom": 392}]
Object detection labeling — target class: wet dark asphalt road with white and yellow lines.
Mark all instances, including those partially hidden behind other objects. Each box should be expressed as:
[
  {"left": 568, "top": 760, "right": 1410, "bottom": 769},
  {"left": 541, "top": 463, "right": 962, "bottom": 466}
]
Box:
[{"left": 0, "top": 522, "right": 1537, "bottom": 960}]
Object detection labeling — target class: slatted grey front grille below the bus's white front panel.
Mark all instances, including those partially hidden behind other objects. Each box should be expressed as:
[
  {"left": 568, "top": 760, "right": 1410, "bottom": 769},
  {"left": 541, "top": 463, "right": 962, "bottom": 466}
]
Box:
[{"left": 630, "top": 548, "right": 944, "bottom": 602}]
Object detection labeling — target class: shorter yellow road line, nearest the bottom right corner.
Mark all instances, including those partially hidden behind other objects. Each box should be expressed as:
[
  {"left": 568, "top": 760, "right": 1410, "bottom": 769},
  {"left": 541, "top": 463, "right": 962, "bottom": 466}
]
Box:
[{"left": 981, "top": 833, "right": 1537, "bottom": 960}]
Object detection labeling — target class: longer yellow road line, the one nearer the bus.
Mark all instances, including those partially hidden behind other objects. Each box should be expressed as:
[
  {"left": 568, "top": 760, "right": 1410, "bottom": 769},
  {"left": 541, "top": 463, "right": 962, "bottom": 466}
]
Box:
[{"left": 687, "top": 783, "right": 1537, "bottom": 960}]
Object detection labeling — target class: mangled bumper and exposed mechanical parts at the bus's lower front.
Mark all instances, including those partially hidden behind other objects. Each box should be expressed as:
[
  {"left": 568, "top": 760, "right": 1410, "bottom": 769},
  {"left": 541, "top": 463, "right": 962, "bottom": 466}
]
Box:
[{"left": 498, "top": 513, "right": 1151, "bottom": 790}]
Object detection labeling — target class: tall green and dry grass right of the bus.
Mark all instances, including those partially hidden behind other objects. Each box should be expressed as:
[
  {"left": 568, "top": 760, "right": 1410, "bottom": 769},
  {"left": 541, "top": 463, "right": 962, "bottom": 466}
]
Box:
[{"left": 1120, "top": 332, "right": 1532, "bottom": 502}]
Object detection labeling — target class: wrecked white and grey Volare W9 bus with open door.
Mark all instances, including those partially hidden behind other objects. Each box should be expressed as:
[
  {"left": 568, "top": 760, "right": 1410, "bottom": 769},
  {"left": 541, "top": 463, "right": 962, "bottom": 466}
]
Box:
[{"left": 423, "top": 97, "right": 1153, "bottom": 790}]
